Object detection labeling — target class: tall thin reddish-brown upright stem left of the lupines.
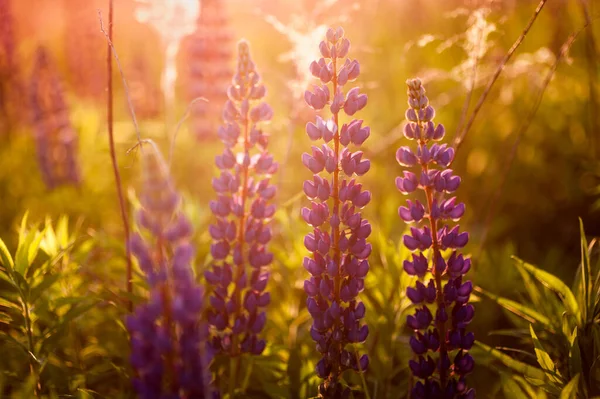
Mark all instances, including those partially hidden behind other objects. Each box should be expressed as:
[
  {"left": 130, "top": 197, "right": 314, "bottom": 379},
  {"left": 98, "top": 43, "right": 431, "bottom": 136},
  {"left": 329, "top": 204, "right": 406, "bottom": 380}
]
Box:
[{"left": 99, "top": 0, "right": 133, "bottom": 312}]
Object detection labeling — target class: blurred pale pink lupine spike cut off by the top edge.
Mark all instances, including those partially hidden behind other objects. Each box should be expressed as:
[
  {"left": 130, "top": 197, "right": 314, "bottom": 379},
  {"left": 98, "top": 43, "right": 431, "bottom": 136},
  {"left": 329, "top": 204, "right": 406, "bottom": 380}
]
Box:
[{"left": 180, "top": 0, "right": 232, "bottom": 140}]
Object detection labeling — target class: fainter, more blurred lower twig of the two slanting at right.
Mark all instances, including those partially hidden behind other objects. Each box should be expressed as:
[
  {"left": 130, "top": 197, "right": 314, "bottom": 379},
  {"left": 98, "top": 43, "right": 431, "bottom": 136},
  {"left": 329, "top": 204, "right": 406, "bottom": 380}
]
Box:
[{"left": 476, "top": 24, "right": 589, "bottom": 258}]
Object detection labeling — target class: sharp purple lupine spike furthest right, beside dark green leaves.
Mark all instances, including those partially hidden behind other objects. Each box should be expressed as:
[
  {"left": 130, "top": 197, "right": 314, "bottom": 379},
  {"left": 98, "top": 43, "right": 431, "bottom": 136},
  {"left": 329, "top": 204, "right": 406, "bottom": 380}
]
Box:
[{"left": 396, "top": 79, "right": 475, "bottom": 399}]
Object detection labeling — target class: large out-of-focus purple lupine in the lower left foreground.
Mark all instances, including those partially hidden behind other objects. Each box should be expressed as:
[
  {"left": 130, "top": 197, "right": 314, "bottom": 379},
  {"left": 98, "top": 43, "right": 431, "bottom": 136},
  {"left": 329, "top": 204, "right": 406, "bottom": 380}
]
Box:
[{"left": 127, "top": 145, "right": 213, "bottom": 399}]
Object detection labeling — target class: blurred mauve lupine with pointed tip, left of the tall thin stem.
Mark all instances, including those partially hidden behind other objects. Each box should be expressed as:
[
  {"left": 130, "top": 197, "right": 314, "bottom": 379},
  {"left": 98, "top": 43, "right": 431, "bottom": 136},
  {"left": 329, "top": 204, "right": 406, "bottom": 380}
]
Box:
[{"left": 29, "top": 47, "right": 81, "bottom": 188}]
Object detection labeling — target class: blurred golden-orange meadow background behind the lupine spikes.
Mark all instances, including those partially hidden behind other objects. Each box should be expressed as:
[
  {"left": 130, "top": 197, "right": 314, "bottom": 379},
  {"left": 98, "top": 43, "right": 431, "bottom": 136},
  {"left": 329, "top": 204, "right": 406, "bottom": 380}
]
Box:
[{"left": 0, "top": 0, "right": 600, "bottom": 398}]
